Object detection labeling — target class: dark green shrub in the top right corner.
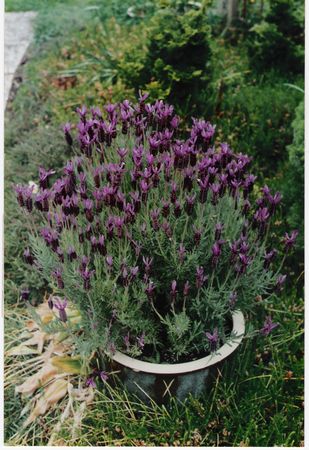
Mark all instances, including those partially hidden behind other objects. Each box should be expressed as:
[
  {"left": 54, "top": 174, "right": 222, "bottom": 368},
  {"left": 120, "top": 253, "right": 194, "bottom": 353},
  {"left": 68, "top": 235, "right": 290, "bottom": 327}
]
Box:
[{"left": 248, "top": 0, "right": 304, "bottom": 73}]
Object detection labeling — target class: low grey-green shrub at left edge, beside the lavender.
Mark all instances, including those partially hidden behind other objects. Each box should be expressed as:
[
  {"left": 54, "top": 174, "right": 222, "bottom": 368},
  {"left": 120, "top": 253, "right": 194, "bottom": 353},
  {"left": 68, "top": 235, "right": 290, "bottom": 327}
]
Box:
[{"left": 4, "top": 126, "right": 68, "bottom": 304}]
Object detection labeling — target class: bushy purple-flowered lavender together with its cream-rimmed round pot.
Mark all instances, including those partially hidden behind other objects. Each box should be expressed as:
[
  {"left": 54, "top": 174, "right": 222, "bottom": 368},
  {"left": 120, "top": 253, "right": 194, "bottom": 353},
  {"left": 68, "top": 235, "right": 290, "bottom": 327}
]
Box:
[{"left": 15, "top": 95, "right": 297, "bottom": 401}]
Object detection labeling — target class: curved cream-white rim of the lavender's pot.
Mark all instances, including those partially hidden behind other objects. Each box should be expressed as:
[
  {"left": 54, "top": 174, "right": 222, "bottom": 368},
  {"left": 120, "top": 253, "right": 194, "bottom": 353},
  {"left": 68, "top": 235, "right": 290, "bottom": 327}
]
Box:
[{"left": 111, "top": 310, "right": 245, "bottom": 375}]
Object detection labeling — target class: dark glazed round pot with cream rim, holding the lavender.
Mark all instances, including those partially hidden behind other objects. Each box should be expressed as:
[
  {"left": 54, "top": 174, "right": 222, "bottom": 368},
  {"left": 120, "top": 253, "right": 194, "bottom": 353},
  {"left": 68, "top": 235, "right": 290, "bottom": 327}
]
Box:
[{"left": 109, "top": 311, "right": 245, "bottom": 404}]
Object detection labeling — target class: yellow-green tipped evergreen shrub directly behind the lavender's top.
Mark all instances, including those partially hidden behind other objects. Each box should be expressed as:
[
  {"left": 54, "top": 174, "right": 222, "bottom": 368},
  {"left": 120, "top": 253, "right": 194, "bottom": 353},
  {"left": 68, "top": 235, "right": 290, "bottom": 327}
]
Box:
[{"left": 118, "top": 1, "right": 211, "bottom": 115}]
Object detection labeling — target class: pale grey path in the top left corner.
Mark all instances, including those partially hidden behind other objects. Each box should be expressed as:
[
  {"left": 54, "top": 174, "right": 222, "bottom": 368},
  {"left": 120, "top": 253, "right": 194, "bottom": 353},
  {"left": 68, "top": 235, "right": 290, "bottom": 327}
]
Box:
[{"left": 4, "top": 11, "right": 36, "bottom": 105}]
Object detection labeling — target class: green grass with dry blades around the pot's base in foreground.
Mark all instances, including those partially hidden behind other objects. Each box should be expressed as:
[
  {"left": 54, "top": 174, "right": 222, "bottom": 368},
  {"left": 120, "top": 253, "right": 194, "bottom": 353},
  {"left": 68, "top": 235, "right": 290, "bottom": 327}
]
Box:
[{"left": 5, "top": 295, "right": 304, "bottom": 447}]
